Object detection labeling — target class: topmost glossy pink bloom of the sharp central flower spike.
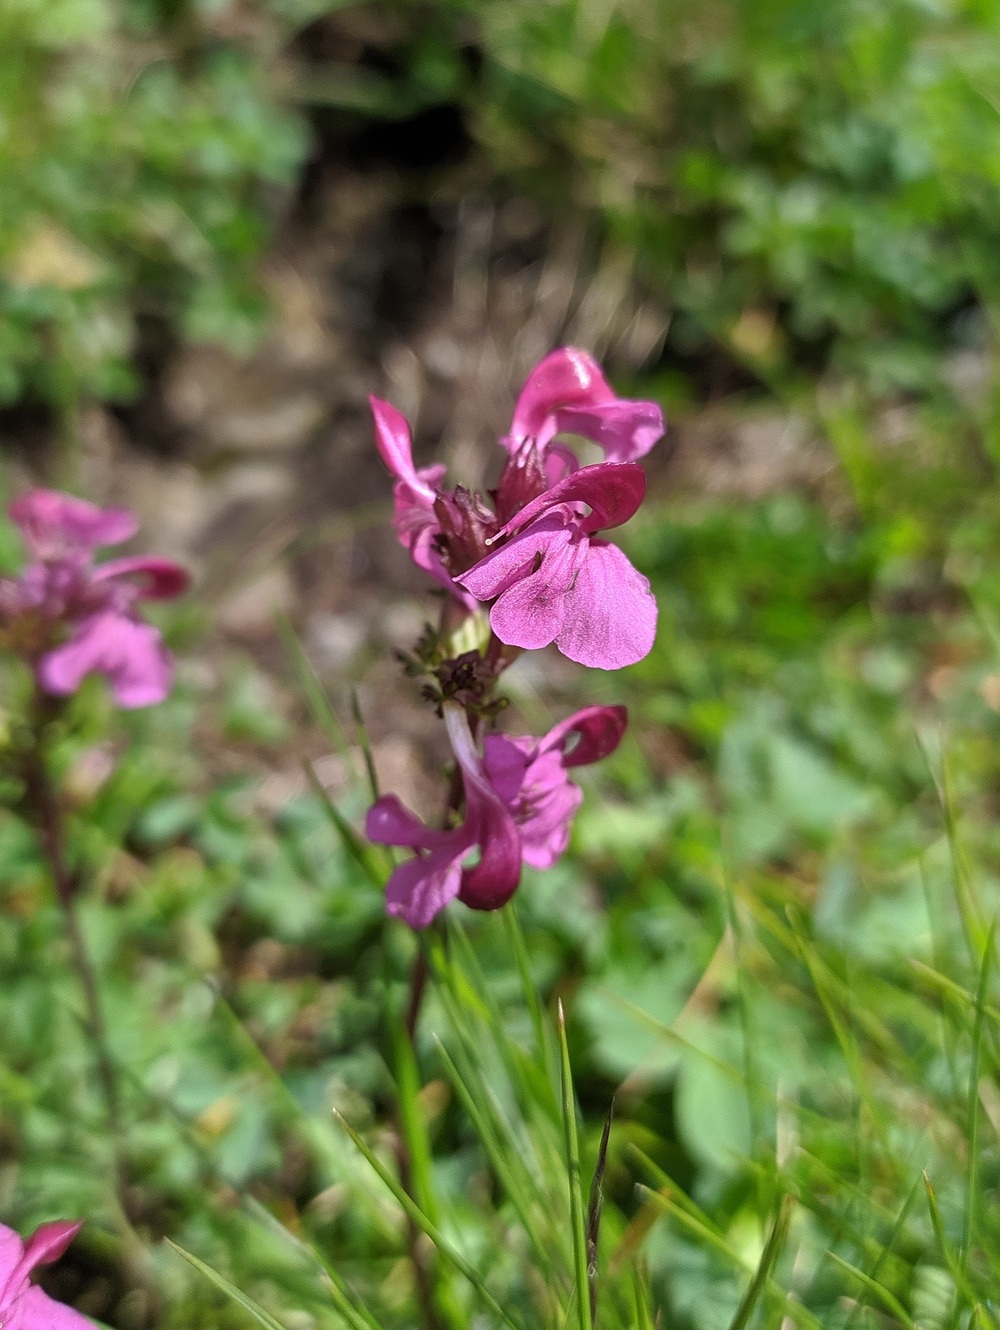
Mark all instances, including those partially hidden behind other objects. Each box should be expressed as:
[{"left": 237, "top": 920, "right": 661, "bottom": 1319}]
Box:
[{"left": 501, "top": 347, "right": 664, "bottom": 462}]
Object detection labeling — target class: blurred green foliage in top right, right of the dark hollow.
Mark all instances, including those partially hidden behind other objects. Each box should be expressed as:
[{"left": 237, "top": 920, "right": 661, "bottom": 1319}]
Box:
[{"left": 337, "top": 0, "right": 1000, "bottom": 392}]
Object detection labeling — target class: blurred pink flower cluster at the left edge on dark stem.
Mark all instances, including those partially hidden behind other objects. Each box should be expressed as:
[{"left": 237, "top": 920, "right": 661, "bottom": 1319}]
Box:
[{"left": 0, "top": 489, "right": 188, "bottom": 708}]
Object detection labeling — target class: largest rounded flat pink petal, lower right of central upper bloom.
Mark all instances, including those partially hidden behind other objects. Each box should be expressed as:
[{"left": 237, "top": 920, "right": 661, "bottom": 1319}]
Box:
[{"left": 555, "top": 541, "right": 657, "bottom": 669}]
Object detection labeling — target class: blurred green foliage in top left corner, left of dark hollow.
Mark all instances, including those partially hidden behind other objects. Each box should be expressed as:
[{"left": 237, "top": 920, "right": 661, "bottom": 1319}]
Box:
[{"left": 0, "top": 0, "right": 307, "bottom": 406}]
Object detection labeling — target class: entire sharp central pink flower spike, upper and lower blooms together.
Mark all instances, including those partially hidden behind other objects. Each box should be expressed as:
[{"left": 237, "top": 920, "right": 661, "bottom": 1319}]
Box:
[{"left": 366, "top": 347, "right": 664, "bottom": 928}]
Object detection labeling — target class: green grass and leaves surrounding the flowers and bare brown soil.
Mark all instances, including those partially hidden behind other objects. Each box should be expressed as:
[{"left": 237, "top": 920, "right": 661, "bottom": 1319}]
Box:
[{"left": 0, "top": 0, "right": 1000, "bottom": 1330}]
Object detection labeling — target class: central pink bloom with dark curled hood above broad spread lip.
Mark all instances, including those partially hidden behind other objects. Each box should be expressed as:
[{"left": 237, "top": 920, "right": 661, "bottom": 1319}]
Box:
[{"left": 456, "top": 462, "right": 657, "bottom": 669}]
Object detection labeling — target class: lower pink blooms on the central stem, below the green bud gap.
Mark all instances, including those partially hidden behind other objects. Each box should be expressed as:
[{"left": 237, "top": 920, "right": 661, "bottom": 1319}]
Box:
[{"left": 364, "top": 702, "right": 628, "bottom": 928}]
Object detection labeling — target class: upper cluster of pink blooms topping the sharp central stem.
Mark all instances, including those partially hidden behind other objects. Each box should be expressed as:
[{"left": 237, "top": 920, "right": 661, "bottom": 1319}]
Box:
[{"left": 371, "top": 347, "right": 664, "bottom": 669}]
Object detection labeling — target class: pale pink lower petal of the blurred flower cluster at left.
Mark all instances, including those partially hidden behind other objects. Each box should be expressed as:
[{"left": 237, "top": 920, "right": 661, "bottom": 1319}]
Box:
[{"left": 39, "top": 610, "right": 173, "bottom": 710}]
